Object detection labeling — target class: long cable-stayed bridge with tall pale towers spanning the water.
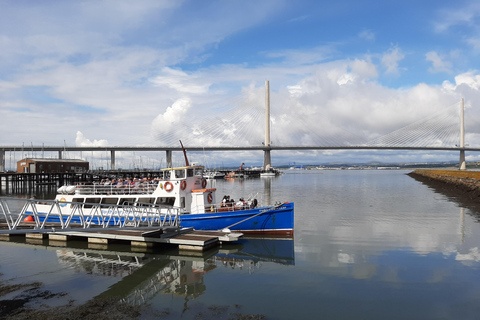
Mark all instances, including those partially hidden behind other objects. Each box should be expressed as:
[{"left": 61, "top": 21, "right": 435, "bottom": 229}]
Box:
[{"left": 0, "top": 81, "right": 480, "bottom": 171}]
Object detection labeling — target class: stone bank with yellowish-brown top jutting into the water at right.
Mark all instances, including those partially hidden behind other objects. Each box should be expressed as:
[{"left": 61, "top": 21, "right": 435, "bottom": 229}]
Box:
[{"left": 408, "top": 169, "right": 480, "bottom": 200}]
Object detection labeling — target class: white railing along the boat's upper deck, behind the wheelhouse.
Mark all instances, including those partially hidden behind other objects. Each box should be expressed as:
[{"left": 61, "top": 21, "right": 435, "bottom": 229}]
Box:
[{"left": 71, "top": 184, "right": 157, "bottom": 195}]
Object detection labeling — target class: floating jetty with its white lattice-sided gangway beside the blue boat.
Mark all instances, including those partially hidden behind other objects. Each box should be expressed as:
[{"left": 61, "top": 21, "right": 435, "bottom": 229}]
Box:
[{"left": 0, "top": 197, "right": 243, "bottom": 251}]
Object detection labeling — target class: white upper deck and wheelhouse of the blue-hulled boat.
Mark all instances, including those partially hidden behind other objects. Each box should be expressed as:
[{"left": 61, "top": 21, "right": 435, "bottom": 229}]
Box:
[{"left": 56, "top": 166, "right": 216, "bottom": 214}]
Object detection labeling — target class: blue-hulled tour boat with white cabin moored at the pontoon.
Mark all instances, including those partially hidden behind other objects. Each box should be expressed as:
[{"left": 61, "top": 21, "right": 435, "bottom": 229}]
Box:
[{"left": 38, "top": 162, "right": 294, "bottom": 235}]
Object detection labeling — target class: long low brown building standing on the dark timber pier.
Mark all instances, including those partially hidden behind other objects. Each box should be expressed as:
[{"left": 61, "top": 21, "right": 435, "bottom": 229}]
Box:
[{"left": 17, "top": 158, "right": 89, "bottom": 173}]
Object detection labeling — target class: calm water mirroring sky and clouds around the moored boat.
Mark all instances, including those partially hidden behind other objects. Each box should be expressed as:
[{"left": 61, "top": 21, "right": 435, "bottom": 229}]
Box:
[{"left": 0, "top": 170, "right": 480, "bottom": 319}]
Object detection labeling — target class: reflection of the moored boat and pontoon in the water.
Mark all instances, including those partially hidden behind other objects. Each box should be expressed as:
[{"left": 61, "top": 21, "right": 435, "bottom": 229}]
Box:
[{"left": 53, "top": 238, "right": 295, "bottom": 305}]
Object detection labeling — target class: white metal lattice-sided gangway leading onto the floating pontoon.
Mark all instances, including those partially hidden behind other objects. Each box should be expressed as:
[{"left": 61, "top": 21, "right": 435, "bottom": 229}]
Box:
[{"left": 0, "top": 197, "right": 181, "bottom": 234}]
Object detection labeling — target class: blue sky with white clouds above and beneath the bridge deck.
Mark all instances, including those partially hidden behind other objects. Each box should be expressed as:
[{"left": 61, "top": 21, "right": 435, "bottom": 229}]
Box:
[{"left": 0, "top": 0, "right": 480, "bottom": 167}]
